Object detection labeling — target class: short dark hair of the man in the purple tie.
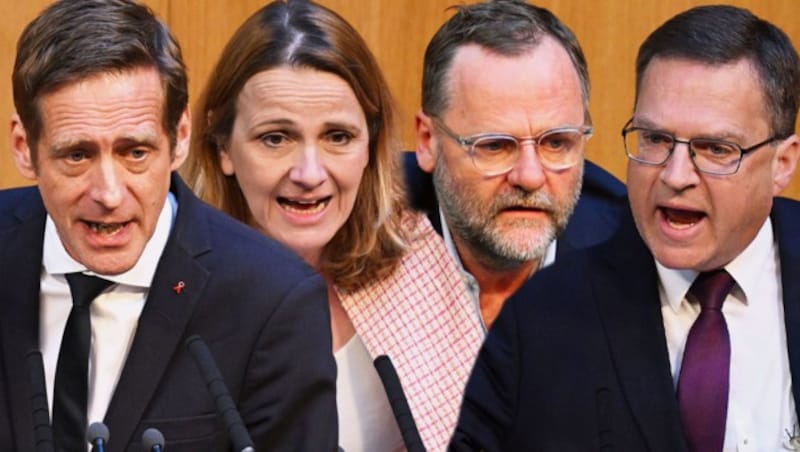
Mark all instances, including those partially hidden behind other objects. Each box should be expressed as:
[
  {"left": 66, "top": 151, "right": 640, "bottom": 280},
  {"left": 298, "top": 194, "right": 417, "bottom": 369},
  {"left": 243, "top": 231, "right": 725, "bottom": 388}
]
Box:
[{"left": 636, "top": 5, "right": 800, "bottom": 137}]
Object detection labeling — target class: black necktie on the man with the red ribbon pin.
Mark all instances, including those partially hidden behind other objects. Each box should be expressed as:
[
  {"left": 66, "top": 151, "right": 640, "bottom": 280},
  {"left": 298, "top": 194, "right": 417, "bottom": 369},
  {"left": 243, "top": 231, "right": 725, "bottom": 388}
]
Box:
[{"left": 53, "top": 273, "right": 112, "bottom": 452}]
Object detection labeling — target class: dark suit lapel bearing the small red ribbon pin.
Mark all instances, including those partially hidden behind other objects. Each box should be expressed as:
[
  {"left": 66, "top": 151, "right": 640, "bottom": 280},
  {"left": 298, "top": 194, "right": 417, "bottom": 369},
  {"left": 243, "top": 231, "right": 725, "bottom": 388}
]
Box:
[{"left": 105, "top": 177, "right": 210, "bottom": 450}]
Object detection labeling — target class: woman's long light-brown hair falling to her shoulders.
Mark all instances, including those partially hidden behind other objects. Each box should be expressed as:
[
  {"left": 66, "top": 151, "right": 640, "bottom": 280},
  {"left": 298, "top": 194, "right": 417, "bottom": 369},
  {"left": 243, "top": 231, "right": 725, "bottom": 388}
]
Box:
[{"left": 182, "top": 0, "right": 409, "bottom": 290}]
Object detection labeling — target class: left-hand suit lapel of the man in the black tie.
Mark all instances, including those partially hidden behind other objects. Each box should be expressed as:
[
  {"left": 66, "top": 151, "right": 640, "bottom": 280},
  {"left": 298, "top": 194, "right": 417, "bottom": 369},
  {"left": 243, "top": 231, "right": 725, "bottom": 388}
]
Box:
[{"left": 0, "top": 189, "right": 46, "bottom": 449}]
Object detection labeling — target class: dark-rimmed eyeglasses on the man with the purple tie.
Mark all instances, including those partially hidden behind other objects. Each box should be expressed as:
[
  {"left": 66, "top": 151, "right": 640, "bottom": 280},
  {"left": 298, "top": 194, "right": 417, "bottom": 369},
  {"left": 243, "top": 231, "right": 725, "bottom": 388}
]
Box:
[{"left": 622, "top": 118, "right": 781, "bottom": 176}]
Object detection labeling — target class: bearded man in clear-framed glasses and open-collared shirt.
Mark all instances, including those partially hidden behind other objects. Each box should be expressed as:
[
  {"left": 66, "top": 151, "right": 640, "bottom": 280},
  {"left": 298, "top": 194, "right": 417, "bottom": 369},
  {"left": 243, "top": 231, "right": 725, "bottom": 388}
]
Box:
[{"left": 412, "top": 1, "right": 625, "bottom": 327}]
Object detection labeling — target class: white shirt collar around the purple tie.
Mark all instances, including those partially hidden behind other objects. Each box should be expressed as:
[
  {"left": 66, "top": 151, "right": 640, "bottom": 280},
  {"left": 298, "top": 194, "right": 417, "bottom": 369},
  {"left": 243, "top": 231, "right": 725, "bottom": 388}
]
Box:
[{"left": 656, "top": 217, "right": 777, "bottom": 312}]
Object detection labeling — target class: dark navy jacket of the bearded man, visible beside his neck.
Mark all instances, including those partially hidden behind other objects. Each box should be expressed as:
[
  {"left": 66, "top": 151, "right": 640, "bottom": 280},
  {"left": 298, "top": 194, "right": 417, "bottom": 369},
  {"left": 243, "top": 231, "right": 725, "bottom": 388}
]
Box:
[{"left": 403, "top": 152, "right": 627, "bottom": 259}]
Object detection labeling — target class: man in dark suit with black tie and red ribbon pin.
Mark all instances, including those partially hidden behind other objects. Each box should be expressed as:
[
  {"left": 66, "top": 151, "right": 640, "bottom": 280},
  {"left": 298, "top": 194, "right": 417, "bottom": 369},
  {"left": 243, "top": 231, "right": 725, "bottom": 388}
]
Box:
[{"left": 0, "top": 0, "right": 337, "bottom": 452}]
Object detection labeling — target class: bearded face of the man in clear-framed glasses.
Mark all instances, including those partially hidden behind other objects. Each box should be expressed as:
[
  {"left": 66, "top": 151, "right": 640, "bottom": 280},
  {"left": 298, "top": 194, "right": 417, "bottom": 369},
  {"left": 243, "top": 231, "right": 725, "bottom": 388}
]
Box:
[{"left": 417, "top": 38, "right": 585, "bottom": 267}]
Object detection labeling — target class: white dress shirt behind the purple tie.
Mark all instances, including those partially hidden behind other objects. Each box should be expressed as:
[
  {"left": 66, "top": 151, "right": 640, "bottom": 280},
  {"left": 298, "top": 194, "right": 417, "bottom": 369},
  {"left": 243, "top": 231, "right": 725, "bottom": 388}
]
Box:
[{"left": 656, "top": 219, "right": 800, "bottom": 452}]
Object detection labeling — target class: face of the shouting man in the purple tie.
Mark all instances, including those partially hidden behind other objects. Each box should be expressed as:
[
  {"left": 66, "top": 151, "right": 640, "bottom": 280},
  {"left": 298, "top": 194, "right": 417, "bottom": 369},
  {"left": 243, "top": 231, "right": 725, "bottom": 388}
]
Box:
[{"left": 628, "top": 58, "right": 798, "bottom": 271}]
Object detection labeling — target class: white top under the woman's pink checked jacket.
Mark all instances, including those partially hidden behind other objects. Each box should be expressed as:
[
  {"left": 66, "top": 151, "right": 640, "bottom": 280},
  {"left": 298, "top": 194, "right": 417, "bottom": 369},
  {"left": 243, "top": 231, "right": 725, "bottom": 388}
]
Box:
[{"left": 334, "top": 334, "right": 405, "bottom": 452}]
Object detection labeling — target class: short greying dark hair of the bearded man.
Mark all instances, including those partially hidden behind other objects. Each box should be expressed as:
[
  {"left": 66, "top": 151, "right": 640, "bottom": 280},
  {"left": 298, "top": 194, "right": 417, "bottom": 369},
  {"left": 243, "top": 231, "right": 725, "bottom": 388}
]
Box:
[{"left": 422, "top": 0, "right": 590, "bottom": 119}]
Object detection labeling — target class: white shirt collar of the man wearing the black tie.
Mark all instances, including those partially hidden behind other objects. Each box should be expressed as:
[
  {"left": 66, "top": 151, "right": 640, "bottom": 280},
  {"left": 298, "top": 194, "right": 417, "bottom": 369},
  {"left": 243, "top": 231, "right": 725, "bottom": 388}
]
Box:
[{"left": 42, "top": 192, "right": 178, "bottom": 288}]
